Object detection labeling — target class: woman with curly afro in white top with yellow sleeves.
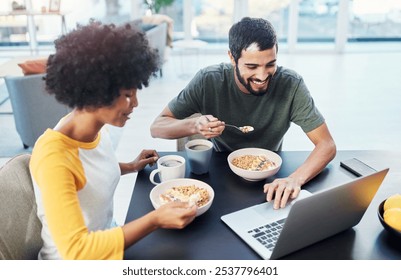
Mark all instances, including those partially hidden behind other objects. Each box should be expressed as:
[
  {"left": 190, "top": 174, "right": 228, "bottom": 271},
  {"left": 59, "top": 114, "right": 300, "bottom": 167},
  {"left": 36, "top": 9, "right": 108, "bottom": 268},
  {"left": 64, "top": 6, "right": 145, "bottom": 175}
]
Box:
[{"left": 30, "top": 21, "right": 196, "bottom": 259}]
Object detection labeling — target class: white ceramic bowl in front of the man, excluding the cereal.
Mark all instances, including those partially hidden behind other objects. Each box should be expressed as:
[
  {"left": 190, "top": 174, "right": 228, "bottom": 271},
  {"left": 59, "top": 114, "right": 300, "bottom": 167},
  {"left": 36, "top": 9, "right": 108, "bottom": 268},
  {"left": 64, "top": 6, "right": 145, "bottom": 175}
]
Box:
[{"left": 227, "top": 148, "right": 283, "bottom": 181}]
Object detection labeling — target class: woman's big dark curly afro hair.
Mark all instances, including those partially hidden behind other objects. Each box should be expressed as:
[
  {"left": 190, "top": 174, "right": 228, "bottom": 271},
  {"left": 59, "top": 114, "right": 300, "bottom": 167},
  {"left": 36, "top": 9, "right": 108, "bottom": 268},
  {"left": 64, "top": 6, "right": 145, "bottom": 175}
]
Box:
[{"left": 45, "top": 20, "right": 160, "bottom": 109}]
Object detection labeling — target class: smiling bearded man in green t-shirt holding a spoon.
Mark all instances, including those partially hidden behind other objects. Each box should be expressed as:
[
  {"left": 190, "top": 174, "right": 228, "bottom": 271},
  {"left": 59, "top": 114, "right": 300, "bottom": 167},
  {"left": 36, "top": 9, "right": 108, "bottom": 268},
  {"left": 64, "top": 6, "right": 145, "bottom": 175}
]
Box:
[{"left": 151, "top": 17, "right": 336, "bottom": 209}]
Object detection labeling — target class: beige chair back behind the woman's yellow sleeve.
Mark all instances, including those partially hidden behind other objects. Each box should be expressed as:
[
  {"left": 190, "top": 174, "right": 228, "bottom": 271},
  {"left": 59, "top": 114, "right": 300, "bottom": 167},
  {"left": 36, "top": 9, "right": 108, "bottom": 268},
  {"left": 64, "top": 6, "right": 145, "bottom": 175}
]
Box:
[{"left": 0, "top": 154, "right": 43, "bottom": 260}]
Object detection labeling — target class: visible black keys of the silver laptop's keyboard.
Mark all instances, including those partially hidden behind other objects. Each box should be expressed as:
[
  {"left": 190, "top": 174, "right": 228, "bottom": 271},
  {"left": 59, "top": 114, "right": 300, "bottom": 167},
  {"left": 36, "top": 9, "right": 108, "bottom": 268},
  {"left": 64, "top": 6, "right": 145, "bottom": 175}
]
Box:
[{"left": 248, "top": 218, "right": 285, "bottom": 251}]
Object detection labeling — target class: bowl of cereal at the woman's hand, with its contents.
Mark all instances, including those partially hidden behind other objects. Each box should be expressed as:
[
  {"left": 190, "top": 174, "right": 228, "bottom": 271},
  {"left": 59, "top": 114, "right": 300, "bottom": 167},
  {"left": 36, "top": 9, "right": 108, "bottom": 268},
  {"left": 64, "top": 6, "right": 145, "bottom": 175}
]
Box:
[{"left": 150, "top": 178, "right": 214, "bottom": 216}]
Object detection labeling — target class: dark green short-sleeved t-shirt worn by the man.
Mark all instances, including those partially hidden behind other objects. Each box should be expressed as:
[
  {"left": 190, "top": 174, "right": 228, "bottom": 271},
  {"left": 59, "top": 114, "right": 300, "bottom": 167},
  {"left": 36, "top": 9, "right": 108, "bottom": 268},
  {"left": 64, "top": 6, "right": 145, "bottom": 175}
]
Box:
[{"left": 168, "top": 63, "right": 324, "bottom": 151}]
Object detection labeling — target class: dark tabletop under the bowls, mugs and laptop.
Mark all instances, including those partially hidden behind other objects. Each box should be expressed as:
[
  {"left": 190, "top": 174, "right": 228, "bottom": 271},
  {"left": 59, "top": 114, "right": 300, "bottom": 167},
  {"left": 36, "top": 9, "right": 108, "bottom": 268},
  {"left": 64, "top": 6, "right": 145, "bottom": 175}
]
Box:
[{"left": 124, "top": 151, "right": 401, "bottom": 260}]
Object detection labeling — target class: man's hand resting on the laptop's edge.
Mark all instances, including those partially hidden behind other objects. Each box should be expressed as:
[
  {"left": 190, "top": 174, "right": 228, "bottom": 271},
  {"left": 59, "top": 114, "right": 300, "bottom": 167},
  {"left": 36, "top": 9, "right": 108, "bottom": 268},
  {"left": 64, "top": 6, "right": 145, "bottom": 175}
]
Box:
[{"left": 263, "top": 177, "right": 301, "bottom": 209}]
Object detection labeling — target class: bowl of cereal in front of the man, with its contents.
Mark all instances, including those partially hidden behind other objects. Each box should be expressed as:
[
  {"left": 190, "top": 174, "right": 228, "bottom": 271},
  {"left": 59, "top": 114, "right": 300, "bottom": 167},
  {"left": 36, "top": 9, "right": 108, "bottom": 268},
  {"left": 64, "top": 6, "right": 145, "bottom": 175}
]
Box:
[{"left": 227, "top": 148, "right": 283, "bottom": 181}]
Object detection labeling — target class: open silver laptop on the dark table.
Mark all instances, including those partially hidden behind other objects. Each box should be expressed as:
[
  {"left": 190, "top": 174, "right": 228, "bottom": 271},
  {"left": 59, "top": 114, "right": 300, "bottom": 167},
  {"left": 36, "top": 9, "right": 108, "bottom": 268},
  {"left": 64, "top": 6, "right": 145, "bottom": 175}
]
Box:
[{"left": 221, "top": 168, "right": 389, "bottom": 259}]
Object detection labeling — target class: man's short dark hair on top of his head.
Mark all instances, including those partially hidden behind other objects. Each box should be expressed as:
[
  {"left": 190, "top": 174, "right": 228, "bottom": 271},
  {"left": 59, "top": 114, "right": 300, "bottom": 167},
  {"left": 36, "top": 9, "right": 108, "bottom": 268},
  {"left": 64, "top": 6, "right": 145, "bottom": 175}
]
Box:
[{"left": 228, "top": 17, "right": 277, "bottom": 62}]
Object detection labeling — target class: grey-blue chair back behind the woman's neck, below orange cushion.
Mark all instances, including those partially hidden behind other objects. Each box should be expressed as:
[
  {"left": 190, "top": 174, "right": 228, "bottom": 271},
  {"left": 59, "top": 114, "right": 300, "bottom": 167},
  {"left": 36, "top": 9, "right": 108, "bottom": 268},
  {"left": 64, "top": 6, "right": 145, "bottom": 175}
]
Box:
[{"left": 4, "top": 74, "right": 71, "bottom": 148}]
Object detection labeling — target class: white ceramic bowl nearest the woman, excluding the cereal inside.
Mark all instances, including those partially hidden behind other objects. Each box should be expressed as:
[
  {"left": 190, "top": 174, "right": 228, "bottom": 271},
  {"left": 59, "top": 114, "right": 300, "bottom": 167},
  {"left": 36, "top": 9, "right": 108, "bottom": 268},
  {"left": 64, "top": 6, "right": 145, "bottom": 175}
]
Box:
[{"left": 150, "top": 178, "right": 214, "bottom": 216}]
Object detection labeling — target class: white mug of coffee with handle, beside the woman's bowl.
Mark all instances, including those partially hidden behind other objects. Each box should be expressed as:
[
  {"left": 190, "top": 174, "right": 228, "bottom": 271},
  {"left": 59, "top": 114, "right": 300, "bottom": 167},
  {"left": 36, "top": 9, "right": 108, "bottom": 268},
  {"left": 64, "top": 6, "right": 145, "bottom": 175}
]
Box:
[{"left": 149, "top": 155, "right": 185, "bottom": 185}]
